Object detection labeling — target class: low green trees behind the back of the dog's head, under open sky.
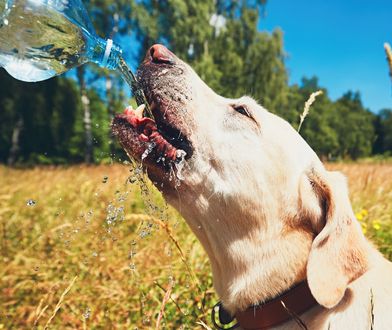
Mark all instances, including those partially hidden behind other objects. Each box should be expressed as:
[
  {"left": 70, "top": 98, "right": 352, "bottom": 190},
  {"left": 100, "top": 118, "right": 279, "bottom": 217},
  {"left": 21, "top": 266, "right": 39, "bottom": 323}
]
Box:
[{"left": 286, "top": 77, "right": 377, "bottom": 160}]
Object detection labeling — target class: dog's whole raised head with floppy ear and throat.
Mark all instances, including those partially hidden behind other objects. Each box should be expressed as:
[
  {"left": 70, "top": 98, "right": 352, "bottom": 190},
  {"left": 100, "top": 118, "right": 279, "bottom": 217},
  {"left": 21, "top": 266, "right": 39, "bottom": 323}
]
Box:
[{"left": 113, "top": 45, "right": 366, "bottom": 308}]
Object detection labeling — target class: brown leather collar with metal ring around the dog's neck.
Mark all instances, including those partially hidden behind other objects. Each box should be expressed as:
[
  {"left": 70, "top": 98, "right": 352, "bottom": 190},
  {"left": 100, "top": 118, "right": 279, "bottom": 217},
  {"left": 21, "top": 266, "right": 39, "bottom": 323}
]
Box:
[{"left": 212, "top": 281, "right": 318, "bottom": 330}]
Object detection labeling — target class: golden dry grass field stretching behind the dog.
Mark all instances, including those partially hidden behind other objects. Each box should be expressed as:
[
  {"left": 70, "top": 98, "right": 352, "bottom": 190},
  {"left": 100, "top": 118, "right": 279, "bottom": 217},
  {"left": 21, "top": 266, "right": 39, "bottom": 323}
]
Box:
[{"left": 0, "top": 163, "right": 392, "bottom": 329}]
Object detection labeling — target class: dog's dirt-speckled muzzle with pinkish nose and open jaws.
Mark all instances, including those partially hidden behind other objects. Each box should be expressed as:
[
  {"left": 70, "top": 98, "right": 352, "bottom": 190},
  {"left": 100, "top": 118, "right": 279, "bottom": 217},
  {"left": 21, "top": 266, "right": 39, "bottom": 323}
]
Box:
[{"left": 112, "top": 45, "right": 194, "bottom": 183}]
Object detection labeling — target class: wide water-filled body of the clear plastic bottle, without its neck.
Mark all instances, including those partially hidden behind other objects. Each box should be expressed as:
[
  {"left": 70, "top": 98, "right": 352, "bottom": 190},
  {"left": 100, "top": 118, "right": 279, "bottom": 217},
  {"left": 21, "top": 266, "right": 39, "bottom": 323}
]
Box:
[{"left": 0, "top": 0, "right": 87, "bottom": 81}]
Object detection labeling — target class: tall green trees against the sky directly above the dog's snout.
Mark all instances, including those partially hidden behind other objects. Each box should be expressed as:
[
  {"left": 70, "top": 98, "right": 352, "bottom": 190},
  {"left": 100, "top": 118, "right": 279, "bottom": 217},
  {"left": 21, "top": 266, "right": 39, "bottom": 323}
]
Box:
[{"left": 132, "top": 0, "right": 288, "bottom": 114}]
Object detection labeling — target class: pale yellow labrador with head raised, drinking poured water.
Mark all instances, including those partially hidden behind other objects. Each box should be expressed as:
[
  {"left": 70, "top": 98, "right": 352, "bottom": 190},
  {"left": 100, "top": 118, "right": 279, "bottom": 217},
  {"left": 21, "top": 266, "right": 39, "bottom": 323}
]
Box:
[{"left": 113, "top": 45, "right": 392, "bottom": 330}]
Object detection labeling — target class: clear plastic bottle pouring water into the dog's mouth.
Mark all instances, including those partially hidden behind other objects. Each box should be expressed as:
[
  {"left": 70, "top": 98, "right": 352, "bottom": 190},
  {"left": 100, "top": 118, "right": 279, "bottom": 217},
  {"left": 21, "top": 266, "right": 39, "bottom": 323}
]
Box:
[{"left": 0, "top": 0, "right": 149, "bottom": 117}]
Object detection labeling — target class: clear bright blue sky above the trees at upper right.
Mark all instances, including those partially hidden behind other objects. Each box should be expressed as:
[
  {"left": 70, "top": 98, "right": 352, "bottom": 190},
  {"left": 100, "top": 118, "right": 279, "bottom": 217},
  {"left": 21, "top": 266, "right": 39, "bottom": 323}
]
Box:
[{"left": 259, "top": 0, "right": 392, "bottom": 112}]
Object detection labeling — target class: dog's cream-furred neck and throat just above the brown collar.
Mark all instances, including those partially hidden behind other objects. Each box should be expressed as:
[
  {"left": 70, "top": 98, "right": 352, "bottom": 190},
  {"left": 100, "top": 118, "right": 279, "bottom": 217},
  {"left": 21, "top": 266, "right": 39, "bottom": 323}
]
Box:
[{"left": 175, "top": 197, "right": 313, "bottom": 313}]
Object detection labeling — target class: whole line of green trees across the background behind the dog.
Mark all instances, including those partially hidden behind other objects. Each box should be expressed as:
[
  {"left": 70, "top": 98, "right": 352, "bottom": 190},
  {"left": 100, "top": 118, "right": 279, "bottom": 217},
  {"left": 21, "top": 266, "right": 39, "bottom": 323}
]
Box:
[{"left": 0, "top": 0, "right": 392, "bottom": 164}]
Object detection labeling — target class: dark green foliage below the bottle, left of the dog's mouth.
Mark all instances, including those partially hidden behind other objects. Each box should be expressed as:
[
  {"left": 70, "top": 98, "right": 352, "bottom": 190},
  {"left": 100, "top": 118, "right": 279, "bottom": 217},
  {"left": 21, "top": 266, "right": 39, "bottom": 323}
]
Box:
[{"left": 0, "top": 71, "right": 109, "bottom": 164}]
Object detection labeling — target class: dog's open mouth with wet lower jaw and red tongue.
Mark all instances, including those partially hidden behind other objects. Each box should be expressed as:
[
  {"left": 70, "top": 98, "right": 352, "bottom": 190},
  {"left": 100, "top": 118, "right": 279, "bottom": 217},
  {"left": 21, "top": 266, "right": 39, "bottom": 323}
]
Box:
[{"left": 112, "top": 96, "right": 193, "bottom": 171}]
